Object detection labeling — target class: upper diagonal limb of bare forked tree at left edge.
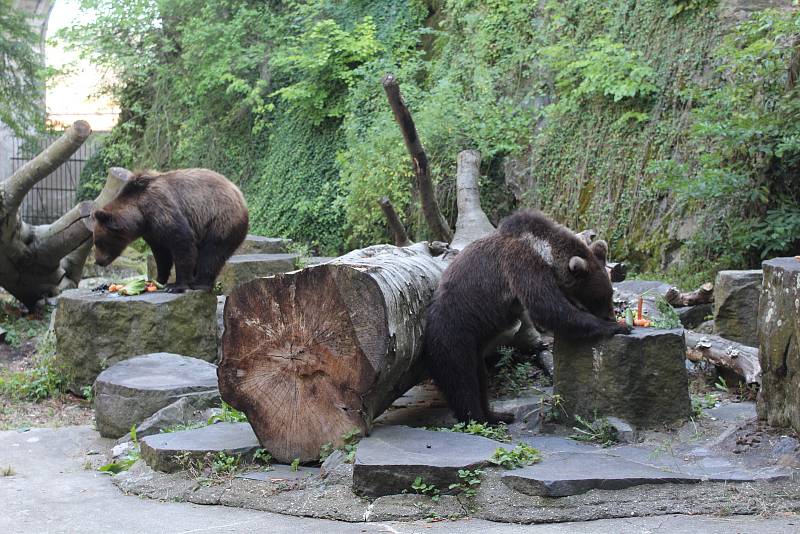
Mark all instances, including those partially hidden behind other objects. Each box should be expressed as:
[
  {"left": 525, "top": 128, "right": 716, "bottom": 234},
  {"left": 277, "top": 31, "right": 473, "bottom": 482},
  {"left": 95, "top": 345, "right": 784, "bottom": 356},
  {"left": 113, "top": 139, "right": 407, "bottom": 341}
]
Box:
[{"left": 3, "top": 121, "right": 92, "bottom": 212}]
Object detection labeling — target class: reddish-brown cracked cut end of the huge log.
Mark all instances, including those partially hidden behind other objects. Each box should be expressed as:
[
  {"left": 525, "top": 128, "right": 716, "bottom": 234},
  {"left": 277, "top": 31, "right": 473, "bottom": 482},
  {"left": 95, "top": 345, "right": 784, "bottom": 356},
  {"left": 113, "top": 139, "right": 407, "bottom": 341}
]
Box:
[{"left": 217, "top": 265, "right": 382, "bottom": 462}]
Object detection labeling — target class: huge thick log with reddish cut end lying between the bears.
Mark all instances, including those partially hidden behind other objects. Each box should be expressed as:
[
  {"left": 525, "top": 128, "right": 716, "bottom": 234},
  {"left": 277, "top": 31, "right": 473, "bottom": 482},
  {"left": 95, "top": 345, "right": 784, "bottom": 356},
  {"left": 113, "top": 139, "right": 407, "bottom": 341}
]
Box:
[{"left": 217, "top": 243, "right": 446, "bottom": 462}]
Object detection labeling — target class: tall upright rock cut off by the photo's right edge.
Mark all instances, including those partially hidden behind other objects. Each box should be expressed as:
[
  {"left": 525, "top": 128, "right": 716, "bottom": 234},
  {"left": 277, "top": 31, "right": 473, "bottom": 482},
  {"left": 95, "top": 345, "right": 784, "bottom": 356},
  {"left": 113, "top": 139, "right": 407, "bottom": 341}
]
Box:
[{"left": 758, "top": 258, "right": 800, "bottom": 432}]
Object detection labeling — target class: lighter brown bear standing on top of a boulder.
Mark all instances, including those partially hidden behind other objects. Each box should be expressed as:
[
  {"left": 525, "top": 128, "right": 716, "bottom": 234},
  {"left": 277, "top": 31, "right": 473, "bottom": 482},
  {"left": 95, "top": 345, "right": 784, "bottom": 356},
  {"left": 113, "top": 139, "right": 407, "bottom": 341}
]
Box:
[{"left": 93, "top": 169, "right": 248, "bottom": 293}]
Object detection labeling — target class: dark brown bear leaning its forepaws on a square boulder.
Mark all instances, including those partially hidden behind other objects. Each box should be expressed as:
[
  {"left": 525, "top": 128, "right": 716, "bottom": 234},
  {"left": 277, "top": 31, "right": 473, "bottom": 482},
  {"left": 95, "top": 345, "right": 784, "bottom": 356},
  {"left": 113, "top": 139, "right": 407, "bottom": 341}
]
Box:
[{"left": 423, "top": 210, "right": 630, "bottom": 423}]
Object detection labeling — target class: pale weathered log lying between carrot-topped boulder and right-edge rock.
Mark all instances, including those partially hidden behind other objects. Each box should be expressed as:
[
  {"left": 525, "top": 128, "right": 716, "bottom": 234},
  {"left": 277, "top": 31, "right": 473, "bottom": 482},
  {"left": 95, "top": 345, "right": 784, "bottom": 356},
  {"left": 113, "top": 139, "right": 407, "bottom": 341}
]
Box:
[{"left": 685, "top": 330, "right": 761, "bottom": 386}]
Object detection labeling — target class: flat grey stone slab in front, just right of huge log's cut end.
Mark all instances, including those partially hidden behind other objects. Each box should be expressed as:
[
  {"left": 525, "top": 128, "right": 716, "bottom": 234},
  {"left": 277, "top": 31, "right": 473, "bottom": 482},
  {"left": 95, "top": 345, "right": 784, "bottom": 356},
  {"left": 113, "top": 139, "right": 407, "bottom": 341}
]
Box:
[{"left": 353, "top": 426, "right": 513, "bottom": 498}]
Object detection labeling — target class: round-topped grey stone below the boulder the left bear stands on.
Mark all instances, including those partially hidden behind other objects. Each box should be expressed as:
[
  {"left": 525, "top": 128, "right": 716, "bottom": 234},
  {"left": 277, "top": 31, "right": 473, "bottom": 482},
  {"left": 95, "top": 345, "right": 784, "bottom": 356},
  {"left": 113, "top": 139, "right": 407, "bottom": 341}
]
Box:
[{"left": 94, "top": 352, "right": 219, "bottom": 438}]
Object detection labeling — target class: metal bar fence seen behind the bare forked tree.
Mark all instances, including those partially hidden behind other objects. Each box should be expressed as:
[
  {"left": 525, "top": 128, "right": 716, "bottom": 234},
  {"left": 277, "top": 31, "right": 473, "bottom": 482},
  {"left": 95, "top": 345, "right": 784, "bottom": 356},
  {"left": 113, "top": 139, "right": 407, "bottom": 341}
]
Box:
[{"left": 11, "top": 134, "right": 102, "bottom": 224}]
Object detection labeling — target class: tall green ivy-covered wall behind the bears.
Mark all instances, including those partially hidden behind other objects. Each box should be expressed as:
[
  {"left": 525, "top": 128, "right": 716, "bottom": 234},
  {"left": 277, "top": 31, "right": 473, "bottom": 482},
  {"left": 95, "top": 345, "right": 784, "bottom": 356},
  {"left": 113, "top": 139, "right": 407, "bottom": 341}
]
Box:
[{"left": 68, "top": 0, "right": 800, "bottom": 284}]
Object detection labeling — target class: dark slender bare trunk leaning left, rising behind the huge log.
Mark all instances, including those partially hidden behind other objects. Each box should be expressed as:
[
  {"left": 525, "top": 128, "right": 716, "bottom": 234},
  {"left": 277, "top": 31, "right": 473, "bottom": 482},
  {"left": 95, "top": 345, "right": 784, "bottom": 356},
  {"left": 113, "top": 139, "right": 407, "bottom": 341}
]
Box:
[{"left": 382, "top": 74, "right": 453, "bottom": 243}]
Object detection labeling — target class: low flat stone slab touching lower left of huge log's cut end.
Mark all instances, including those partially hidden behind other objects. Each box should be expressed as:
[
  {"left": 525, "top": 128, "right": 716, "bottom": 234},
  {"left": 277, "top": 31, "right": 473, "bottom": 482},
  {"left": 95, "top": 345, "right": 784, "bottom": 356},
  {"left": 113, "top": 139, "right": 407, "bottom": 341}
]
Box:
[{"left": 140, "top": 423, "right": 261, "bottom": 473}]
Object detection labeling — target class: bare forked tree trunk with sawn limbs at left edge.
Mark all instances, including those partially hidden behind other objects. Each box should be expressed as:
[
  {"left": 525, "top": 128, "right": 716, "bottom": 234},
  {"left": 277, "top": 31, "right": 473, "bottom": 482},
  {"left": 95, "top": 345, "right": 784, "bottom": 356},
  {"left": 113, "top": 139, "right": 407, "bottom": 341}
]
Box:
[{"left": 0, "top": 121, "right": 131, "bottom": 310}]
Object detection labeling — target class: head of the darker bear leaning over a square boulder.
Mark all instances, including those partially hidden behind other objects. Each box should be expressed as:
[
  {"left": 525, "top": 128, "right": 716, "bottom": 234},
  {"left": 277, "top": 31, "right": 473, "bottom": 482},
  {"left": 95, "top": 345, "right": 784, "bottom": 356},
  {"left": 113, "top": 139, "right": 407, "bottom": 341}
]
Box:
[{"left": 569, "top": 240, "right": 616, "bottom": 321}]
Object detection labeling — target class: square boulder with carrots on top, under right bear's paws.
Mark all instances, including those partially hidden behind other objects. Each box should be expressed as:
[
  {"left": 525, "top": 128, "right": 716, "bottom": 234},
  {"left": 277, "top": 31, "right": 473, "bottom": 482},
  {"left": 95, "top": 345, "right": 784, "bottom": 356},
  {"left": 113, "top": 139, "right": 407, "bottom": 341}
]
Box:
[{"left": 553, "top": 328, "right": 691, "bottom": 428}]
